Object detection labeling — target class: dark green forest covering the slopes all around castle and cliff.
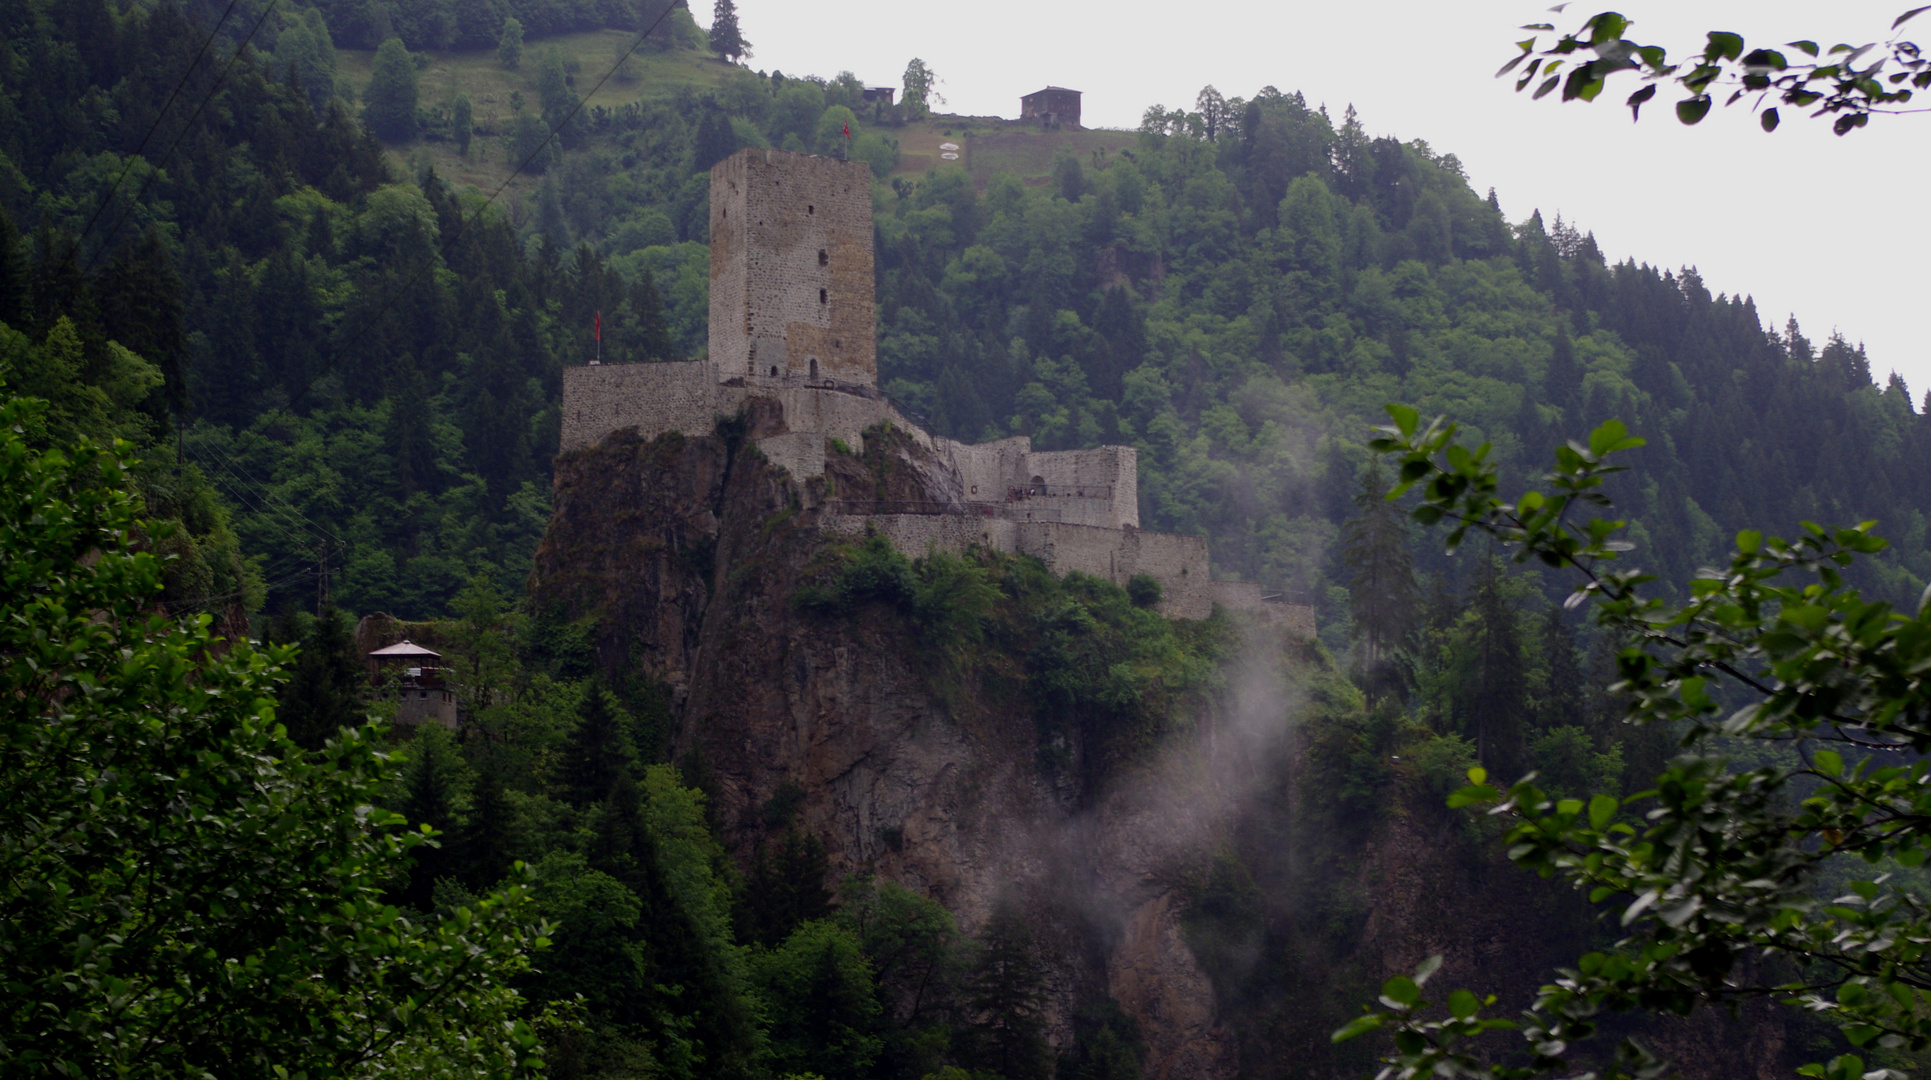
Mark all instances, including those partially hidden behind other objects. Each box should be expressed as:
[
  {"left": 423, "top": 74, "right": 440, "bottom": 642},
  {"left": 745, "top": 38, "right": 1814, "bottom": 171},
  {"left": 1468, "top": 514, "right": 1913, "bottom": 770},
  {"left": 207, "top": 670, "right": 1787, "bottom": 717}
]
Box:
[{"left": 0, "top": 0, "right": 1931, "bottom": 1080}]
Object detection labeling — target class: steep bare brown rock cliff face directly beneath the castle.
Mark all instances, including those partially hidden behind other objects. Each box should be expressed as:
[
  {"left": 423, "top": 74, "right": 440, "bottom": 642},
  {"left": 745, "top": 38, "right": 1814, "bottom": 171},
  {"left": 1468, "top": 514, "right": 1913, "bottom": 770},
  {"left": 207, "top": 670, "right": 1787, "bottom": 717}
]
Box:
[{"left": 533, "top": 402, "right": 1284, "bottom": 1080}]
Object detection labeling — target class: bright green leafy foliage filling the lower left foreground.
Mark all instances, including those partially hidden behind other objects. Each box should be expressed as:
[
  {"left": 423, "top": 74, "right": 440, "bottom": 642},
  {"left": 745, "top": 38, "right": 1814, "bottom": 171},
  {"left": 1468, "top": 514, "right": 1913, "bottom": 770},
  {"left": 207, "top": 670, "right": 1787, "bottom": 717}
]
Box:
[{"left": 0, "top": 398, "right": 541, "bottom": 1076}]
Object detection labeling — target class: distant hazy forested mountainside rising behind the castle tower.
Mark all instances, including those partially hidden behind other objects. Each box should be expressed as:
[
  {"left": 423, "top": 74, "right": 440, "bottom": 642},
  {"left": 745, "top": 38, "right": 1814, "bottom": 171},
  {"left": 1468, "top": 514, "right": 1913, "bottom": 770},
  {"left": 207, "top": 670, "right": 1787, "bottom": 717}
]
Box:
[{"left": 0, "top": 2, "right": 1931, "bottom": 626}]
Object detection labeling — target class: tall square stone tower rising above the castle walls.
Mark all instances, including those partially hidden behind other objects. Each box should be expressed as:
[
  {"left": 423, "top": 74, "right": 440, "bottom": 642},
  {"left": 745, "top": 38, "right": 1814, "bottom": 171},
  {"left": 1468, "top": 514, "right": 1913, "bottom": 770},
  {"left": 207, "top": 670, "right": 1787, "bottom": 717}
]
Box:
[{"left": 711, "top": 149, "right": 879, "bottom": 386}]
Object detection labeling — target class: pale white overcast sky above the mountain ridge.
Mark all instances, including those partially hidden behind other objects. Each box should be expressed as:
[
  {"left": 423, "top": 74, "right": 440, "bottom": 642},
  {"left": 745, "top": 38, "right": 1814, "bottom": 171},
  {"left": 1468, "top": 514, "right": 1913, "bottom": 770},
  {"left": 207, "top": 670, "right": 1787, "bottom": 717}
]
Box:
[{"left": 726, "top": 0, "right": 1931, "bottom": 398}]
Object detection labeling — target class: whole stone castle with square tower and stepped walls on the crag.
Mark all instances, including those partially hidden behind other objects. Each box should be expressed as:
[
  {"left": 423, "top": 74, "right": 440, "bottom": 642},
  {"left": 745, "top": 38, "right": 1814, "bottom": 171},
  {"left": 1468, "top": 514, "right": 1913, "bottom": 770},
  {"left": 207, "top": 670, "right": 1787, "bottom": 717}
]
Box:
[{"left": 562, "top": 149, "right": 1313, "bottom": 638}]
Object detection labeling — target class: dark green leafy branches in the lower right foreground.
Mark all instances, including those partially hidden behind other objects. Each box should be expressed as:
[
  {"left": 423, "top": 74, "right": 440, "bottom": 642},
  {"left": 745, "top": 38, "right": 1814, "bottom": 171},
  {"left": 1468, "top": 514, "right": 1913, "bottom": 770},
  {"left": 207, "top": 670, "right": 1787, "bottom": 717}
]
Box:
[{"left": 1334, "top": 406, "right": 1931, "bottom": 1078}]
